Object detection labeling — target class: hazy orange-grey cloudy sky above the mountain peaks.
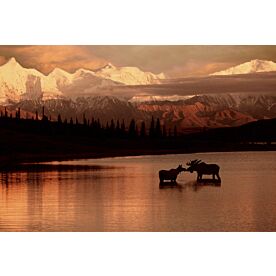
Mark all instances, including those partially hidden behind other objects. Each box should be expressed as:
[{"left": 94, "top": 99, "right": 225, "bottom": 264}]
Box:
[{"left": 0, "top": 45, "right": 276, "bottom": 78}]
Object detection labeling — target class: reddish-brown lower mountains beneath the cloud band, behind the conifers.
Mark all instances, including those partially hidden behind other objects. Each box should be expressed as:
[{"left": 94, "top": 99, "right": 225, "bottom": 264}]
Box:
[{"left": 8, "top": 93, "right": 276, "bottom": 132}]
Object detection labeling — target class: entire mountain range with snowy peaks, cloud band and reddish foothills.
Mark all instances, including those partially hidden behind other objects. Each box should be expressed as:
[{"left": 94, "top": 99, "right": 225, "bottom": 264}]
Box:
[{"left": 0, "top": 58, "right": 276, "bottom": 131}]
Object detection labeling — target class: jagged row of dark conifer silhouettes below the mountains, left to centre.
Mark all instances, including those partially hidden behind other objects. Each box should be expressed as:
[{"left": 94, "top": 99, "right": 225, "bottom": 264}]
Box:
[{"left": 0, "top": 107, "right": 179, "bottom": 139}]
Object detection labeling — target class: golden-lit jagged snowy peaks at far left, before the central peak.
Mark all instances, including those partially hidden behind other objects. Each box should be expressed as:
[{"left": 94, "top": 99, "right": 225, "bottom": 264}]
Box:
[{"left": 0, "top": 58, "right": 114, "bottom": 104}]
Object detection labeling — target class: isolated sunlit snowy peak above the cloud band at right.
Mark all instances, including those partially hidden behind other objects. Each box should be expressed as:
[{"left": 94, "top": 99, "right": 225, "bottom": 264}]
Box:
[{"left": 211, "top": 59, "right": 276, "bottom": 76}]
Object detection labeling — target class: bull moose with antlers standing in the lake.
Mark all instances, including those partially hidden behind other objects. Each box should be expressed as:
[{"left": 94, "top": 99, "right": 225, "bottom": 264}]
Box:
[{"left": 186, "top": 159, "right": 221, "bottom": 181}]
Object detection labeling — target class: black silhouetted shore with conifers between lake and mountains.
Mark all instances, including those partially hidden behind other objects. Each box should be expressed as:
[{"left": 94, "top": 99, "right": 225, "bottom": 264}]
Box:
[{"left": 0, "top": 108, "right": 276, "bottom": 166}]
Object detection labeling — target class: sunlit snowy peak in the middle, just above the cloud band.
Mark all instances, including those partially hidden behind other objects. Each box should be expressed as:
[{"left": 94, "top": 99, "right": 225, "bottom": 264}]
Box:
[{"left": 95, "top": 63, "right": 165, "bottom": 85}]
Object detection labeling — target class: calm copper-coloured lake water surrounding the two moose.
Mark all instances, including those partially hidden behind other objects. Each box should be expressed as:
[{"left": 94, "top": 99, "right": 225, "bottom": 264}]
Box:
[{"left": 0, "top": 152, "right": 276, "bottom": 231}]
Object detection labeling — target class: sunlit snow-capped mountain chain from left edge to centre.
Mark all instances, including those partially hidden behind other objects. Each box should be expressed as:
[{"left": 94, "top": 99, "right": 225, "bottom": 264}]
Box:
[{"left": 0, "top": 58, "right": 165, "bottom": 104}]
